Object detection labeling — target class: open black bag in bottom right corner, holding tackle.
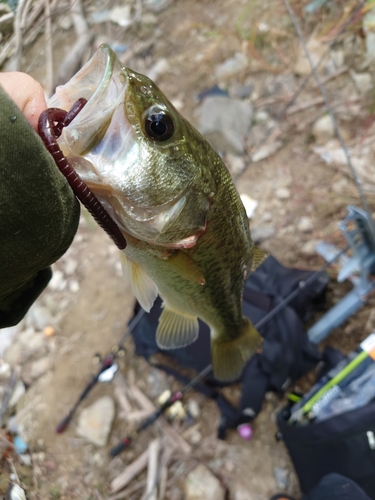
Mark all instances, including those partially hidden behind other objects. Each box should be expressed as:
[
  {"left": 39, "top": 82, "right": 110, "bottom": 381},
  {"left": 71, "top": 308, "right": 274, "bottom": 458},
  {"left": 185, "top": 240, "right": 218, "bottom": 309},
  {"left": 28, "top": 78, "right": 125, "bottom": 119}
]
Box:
[{"left": 277, "top": 386, "right": 375, "bottom": 499}]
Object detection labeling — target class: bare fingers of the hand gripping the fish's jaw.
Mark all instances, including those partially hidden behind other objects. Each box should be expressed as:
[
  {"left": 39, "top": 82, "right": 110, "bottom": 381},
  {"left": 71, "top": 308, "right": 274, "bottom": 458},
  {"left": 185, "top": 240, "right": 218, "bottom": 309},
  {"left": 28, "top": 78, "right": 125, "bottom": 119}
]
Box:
[{"left": 0, "top": 71, "right": 47, "bottom": 131}]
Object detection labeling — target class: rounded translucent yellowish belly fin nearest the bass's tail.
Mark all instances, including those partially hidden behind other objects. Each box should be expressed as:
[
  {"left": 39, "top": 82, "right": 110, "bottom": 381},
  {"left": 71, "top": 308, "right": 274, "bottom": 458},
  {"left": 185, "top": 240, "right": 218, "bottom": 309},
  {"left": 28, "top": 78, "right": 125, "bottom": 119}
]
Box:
[{"left": 156, "top": 305, "right": 199, "bottom": 349}]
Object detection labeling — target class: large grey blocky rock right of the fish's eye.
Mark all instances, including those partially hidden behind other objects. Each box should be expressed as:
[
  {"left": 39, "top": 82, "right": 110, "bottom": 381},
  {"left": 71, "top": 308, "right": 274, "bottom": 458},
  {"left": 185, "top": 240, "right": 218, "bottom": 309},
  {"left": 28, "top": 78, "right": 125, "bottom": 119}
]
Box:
[{"left": 198, "top": 96, "right": 253, "bottom": 155}]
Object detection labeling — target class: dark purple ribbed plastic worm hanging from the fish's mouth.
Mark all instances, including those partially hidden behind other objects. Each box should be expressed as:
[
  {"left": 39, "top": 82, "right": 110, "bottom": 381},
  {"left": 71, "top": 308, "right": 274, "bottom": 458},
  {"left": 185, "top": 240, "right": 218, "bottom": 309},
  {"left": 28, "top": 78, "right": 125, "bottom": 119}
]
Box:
[{"left": 38, "top": 98, "right": 126, "bottom": 250}]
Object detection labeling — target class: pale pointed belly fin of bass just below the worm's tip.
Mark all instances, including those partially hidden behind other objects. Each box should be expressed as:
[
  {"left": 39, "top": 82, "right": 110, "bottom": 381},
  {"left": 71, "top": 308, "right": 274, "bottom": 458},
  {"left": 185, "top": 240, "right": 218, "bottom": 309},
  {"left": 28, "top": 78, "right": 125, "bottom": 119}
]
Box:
[{"left": 121, "top": 252, "right": 158, "bottom": 312}]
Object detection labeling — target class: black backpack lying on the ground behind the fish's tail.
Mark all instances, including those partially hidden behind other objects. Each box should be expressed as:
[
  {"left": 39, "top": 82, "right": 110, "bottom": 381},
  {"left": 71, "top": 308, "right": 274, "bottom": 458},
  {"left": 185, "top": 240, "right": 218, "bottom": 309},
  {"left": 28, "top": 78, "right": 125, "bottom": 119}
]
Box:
[{"left": 130, "top": 256, "right": 329, "bottom": 439}]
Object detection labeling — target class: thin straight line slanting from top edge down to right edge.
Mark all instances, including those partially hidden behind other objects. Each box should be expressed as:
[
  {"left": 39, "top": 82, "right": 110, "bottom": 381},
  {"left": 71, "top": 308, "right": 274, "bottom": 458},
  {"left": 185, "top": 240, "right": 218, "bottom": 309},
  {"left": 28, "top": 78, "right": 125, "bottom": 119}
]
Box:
[{"left": 284, "top": 0, "right": 373, "bottom": 224}]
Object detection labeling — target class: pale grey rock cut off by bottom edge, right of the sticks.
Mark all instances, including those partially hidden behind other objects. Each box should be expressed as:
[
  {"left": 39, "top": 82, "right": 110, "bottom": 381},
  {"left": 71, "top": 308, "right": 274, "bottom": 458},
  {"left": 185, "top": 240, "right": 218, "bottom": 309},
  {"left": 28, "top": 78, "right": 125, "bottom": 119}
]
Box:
[{"left": 185, "top": 464, "right": 225, "bottom": 500}]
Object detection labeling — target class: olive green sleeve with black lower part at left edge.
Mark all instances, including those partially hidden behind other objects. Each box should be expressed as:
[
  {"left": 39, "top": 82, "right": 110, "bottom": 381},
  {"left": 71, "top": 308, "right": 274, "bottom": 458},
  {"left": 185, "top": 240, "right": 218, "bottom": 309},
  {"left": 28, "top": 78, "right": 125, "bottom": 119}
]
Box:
[{"left": 0, "top": 87, "right": 79, "bottom": 328}]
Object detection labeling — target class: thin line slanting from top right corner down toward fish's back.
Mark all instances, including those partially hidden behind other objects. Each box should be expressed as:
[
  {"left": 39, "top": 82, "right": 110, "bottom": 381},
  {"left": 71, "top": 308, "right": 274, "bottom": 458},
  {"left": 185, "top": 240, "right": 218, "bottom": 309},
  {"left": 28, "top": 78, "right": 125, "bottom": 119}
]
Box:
[{"left": 233, "top": 0, "right": 365, "bottom": 182}]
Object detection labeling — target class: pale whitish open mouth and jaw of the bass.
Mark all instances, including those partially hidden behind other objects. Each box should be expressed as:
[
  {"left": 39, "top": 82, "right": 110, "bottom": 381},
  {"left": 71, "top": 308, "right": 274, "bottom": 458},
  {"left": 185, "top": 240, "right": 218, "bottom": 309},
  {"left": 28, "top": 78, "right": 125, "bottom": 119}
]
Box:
[{"left": 48, "top": 44, "right": 130, "bottom": 157}]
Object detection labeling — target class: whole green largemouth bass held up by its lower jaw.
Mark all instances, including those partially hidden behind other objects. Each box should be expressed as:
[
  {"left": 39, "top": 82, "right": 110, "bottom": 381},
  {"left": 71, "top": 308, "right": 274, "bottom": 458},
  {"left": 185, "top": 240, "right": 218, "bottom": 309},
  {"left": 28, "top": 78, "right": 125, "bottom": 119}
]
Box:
[{"left": 48, "top": 45, "right": 262, "bottom": 380}]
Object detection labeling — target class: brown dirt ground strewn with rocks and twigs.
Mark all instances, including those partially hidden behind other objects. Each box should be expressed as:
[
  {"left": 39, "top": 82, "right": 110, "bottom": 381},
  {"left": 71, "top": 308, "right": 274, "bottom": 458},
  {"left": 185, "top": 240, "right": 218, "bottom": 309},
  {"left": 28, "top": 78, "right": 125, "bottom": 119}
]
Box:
[{"left": 0, "top": 0, "right": 375, "bottom": 500}]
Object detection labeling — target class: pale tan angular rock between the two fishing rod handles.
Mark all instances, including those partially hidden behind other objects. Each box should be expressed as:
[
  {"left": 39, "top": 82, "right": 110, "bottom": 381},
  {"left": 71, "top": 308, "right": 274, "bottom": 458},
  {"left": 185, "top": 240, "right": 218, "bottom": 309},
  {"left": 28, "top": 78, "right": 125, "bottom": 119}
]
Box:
[{"left": 77, "top": 396, "right": 115, "bottom": 446}]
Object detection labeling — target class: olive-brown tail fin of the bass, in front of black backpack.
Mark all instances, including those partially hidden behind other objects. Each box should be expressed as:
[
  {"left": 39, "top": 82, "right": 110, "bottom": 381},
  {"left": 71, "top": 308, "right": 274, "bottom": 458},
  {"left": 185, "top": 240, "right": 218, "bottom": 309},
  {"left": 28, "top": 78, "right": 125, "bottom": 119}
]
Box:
[{"left": 211, "top": 318, "right": 263, "bottom": 382}]
